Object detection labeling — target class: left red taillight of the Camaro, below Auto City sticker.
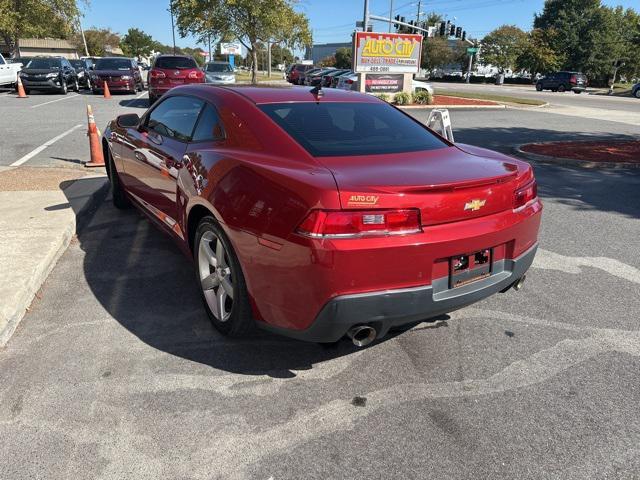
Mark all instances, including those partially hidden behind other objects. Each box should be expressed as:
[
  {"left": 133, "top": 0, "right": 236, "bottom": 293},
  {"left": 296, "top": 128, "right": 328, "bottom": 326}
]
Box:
[{"left": 296, "top": 209, "right": 422, "bottom": 238}]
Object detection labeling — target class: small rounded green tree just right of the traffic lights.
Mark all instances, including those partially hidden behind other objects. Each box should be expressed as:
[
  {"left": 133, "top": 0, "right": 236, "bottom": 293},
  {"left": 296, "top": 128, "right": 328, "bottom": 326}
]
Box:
[{"left": 482, "top": 25, "right": 527, "bottom": 72}]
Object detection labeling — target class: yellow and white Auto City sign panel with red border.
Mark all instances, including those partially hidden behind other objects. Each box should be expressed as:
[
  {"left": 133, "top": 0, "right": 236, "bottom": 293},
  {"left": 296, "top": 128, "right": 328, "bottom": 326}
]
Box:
[{"left": 354, "top": 32, "right": 422, "bottom": 73}]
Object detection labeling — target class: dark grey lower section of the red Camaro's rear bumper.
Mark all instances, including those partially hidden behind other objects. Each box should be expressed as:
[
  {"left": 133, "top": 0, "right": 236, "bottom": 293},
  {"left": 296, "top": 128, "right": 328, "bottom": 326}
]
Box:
[{"left": 258, "top": 244, "right": 538, "bottom": 343}]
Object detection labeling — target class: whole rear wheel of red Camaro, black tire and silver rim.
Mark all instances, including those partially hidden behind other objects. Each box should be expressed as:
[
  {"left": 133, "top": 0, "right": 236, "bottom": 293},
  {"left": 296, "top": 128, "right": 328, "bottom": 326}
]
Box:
[{"left": 193, "top": 217, "right": 253, "bottom": 337}]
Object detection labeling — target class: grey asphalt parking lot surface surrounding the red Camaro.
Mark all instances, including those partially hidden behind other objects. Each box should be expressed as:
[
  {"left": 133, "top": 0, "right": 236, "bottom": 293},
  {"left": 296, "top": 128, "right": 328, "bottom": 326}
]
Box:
[{"left": 0, "top": 86, "right": 640, "bottom": 480}]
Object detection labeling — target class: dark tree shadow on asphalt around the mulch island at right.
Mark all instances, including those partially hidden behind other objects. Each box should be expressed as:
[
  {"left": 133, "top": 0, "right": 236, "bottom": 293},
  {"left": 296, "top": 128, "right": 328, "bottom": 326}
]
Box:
[{"left": 455, "top": 127, "right": 640, "bottom": 218}]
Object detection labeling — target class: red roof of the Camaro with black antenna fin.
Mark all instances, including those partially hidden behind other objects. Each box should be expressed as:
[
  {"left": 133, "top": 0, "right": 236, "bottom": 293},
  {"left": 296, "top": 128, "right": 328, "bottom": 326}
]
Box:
[{"left": 172, "top": 84, "right": 380, "bottom": 104}]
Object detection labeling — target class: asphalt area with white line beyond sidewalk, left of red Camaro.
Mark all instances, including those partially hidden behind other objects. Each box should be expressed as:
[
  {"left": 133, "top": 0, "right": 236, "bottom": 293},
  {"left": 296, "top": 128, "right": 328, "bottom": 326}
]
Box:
[{"left": 0, "top": 91, "right": 148, "bottom": 167}]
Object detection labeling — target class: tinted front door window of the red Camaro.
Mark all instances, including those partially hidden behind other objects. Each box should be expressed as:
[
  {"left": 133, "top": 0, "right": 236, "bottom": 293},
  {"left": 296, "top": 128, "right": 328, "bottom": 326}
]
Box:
[{"left": 145, "top": 97, "right": 203, "bottom": 142}]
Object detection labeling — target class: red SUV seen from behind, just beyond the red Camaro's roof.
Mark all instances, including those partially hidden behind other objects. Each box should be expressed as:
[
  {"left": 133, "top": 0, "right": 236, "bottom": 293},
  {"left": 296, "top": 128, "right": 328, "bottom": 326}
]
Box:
[{"left": 148, "top": 55, "right": 204, "bottom": 104}]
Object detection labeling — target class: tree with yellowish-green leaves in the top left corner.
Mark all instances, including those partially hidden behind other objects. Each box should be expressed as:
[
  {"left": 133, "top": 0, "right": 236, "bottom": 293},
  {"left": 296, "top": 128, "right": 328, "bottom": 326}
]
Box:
[{"left": 0, "top": 0, "right": 80, "bottom": 53}]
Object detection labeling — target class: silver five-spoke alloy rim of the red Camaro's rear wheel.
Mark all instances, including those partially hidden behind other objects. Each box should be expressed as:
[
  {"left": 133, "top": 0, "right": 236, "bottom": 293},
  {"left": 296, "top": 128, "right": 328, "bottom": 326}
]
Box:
[{"left": 198, "top": 231, "right": 234, "bottom": 322}]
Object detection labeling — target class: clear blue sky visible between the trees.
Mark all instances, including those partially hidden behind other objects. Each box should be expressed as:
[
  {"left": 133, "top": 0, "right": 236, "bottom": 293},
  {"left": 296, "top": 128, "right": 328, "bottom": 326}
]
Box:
[{"left": 83, "top": 0, "right": 640, "bottom": 47}]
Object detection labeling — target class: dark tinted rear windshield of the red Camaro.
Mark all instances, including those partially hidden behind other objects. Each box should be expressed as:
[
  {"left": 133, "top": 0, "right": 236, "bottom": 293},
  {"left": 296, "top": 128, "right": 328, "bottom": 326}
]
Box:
[{"left": 260, "top": 101, "right": 448, "bottom": 157}]
